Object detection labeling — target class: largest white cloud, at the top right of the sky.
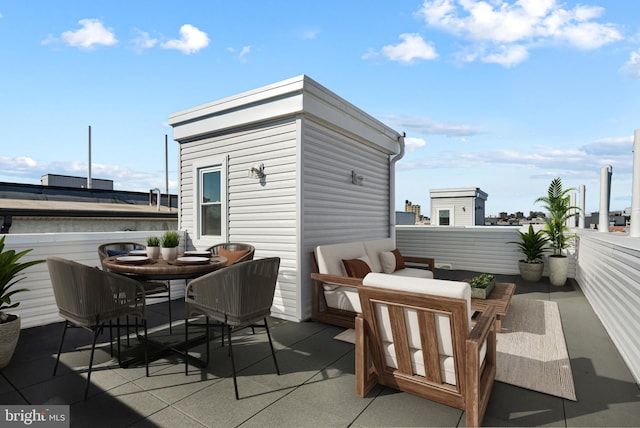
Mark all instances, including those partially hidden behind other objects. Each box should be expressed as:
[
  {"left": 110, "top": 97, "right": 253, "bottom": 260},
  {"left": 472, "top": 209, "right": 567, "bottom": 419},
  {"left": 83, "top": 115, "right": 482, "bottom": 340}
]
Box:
[{"left": 417, "top": 0, "right": 622, "bottom": 67}]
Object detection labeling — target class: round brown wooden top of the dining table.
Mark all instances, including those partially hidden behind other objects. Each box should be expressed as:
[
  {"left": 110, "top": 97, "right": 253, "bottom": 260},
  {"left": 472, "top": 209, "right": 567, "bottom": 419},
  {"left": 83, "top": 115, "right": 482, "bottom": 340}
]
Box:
[{"left": 103, "top": 256, "right": 227, "bottom": 280}]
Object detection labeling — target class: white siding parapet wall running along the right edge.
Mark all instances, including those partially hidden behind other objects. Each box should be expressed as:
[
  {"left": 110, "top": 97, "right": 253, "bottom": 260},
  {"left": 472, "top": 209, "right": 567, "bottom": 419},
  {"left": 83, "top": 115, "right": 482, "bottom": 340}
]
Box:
[{"left": 576, "top": 230, "right": 640, "bottom": 384}]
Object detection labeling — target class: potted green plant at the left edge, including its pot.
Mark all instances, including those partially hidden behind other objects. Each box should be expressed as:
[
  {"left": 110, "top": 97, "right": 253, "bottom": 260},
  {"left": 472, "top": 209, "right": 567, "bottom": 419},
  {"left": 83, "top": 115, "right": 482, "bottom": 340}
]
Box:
[{"left": 0, "top": 236, "right": 44, "bottom": 368}]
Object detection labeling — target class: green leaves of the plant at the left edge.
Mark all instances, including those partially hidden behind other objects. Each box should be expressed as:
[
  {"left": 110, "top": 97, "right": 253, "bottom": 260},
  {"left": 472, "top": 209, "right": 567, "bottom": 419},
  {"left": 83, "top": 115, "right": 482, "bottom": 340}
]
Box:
[{"left": 0, "top": 236, "right": 45, "bottom": 323}]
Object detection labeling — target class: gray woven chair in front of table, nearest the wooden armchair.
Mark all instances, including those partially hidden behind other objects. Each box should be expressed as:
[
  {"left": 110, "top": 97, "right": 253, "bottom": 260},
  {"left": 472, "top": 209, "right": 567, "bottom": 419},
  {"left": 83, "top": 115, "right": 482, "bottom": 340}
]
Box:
[{"left": 184, "top": 257, "right": 280, "bottom": 400}]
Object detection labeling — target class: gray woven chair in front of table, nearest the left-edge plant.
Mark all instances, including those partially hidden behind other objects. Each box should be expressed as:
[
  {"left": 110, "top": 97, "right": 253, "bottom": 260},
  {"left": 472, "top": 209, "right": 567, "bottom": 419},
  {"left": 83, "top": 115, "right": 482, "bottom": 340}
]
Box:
[{"left": 47, "top": 257, "right": 149, "bottom": 400}]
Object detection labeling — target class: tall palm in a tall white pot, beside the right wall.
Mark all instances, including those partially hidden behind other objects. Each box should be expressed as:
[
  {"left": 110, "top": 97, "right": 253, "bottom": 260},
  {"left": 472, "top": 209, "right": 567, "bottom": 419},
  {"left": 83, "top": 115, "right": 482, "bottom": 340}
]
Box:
[{"left": 535, "top": 177, "right": 579, "bottom": 286}]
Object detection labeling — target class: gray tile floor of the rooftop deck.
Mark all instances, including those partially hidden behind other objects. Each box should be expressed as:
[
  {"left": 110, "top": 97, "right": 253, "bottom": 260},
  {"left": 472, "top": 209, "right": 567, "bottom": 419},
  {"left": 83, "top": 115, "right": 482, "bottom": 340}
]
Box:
[{"left": 0, "top": 271, "right": 640, "bottom": 428}]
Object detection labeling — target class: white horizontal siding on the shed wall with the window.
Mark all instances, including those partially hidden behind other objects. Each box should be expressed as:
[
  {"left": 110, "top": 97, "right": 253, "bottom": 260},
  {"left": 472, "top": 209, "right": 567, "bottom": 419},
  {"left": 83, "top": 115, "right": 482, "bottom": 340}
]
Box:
[{"left": 180, "top": 118, "right": 298, "bottom": 319}]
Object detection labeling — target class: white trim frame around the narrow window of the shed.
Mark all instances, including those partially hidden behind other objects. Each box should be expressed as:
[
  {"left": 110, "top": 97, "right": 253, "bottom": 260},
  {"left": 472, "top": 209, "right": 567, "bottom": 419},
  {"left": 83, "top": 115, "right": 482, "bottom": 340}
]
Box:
[{"left": 191, "top": 156, "right": 229, "bottom": 246}]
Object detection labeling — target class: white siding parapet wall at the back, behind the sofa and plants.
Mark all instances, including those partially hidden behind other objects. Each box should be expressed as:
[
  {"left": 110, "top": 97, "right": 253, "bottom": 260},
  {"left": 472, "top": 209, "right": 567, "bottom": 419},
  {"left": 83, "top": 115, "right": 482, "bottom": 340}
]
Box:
[{"left": 396, "top": 226, "right": 576, "bottom": 278}]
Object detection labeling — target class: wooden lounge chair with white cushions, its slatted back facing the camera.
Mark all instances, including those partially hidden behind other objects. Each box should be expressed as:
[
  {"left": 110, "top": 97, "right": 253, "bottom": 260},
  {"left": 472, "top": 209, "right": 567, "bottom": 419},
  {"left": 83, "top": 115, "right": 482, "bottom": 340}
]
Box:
[{"left": 355, "top": 273, "right": 496, "bottom": 427}]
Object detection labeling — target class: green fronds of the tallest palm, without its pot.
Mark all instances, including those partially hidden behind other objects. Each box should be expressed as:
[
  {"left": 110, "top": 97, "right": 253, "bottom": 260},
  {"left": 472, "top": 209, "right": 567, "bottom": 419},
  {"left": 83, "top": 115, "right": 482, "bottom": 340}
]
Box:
[{"left": 535, "top": 177, "right": 580, "bottom": 256}]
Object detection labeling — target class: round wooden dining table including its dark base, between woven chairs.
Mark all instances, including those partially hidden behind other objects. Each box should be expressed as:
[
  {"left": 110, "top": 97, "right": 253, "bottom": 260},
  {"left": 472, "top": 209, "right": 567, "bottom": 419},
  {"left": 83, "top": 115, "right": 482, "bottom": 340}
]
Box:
[{"left": 103, "top": 255, "right": 227, "bottom": 367}]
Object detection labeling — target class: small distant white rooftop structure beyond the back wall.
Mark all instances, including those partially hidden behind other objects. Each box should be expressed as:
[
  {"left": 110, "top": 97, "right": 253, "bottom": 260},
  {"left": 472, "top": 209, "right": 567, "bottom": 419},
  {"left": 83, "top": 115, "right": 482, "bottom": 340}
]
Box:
[{"left": 429, "top": 187, "right": 488, "bottom": 226}]
